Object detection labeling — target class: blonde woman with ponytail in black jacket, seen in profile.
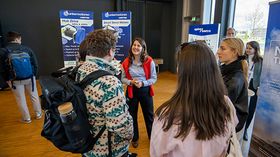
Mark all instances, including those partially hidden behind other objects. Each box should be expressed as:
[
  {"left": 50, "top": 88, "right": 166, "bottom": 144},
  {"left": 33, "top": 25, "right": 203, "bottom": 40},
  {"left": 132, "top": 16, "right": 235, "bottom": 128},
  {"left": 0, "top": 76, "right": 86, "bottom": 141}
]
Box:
[{"left": 217, "top": 38, "right": 248, "bottom": 141}]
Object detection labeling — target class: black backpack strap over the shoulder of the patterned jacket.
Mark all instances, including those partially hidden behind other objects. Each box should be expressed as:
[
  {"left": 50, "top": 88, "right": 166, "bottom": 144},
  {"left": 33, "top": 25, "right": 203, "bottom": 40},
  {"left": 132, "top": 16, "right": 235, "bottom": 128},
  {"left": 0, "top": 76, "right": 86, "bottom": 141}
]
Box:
[{"left": 79, "top": 70, "right": 112, "bottom": 89}]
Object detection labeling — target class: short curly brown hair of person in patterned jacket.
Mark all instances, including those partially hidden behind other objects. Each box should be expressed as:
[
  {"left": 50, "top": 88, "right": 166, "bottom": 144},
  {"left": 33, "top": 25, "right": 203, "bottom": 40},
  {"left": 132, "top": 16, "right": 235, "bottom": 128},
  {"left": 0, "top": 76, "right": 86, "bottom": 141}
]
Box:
[{"left": 85, "top": 29, "right": 117, "bottom": 58}]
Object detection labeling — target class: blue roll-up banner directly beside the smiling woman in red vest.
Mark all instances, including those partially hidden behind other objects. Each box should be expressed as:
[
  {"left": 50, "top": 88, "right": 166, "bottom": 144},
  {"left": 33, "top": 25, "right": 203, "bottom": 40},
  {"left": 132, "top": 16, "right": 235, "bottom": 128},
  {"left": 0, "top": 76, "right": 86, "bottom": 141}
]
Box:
[{"left": 102, "top": 12, "right": 131, "bottom": 61}]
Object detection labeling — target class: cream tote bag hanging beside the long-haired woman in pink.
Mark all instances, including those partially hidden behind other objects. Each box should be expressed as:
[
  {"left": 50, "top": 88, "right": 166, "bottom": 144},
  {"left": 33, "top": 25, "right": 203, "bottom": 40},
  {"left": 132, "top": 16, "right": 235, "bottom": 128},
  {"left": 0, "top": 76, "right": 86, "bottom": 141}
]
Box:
[{"left": 226, "top": 100, "right": 243, "bottom": 157}]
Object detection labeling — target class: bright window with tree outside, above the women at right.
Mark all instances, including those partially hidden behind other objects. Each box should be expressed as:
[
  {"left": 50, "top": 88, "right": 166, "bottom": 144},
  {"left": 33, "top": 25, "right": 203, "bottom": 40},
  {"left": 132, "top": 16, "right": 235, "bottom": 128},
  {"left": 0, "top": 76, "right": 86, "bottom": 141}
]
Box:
[{"left": 234, "top": 0, "right": 273, "bottom": 55}]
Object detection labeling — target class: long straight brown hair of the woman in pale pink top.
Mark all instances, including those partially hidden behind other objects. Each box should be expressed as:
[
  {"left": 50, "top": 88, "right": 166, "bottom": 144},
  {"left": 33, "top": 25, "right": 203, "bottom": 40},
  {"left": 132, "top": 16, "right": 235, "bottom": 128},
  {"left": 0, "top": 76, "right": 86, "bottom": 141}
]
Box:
[{"left": 156, "top": 42, "right": 230, "bottom": 140}]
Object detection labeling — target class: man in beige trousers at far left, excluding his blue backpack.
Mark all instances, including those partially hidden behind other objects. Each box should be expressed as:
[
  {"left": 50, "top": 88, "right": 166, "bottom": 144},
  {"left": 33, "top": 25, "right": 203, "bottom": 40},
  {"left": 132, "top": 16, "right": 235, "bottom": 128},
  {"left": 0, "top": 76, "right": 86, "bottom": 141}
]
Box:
[{"left": 5, "top": 31, "right": 42, "bottom": 123}]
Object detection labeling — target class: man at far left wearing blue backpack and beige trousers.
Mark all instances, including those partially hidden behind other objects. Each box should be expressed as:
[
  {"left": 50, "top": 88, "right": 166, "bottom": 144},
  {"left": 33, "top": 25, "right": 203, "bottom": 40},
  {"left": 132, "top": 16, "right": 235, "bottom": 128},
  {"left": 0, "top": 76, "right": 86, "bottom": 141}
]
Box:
[{"left": 4, "top": 32, "right": 42, "bottom": 123}]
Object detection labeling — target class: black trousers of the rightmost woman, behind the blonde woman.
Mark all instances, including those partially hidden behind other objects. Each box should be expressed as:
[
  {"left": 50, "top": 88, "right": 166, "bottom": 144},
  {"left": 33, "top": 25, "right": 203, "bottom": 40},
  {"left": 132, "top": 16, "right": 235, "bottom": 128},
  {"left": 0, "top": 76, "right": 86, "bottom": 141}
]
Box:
[{"left": 245, "top": 79, "right": 258, "bottom": 131}]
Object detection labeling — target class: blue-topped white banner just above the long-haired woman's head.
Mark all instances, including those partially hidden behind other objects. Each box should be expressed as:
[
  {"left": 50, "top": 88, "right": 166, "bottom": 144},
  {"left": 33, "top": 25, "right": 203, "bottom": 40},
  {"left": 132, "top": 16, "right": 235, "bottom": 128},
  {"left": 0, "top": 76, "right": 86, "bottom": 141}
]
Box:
[{"left": 188, "top": 24, "right": 220, "bottom": 54}]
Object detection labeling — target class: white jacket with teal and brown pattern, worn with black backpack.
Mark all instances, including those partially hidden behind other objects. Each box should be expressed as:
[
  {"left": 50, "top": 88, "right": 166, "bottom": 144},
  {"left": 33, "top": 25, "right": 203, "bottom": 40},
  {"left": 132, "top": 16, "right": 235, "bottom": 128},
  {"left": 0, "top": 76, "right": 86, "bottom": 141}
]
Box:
[{"left": 77, "top": 56, "right": 133, "bottom": 157}]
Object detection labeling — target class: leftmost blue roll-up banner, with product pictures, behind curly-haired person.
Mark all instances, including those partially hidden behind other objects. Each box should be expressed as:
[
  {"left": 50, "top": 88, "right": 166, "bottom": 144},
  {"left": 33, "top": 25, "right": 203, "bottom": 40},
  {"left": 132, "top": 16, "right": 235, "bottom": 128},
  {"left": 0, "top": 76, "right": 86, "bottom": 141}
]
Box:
[{"left": 59, "top": 10, "right": 93, "bottom": 67}]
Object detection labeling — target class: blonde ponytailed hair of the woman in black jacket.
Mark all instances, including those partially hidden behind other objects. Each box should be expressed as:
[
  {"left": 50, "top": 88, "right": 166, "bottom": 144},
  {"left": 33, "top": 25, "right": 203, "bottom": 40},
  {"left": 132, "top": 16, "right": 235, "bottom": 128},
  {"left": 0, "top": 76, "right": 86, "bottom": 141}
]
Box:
[{"left": 222, "top": 38, "right": 248, "bottom": 81}]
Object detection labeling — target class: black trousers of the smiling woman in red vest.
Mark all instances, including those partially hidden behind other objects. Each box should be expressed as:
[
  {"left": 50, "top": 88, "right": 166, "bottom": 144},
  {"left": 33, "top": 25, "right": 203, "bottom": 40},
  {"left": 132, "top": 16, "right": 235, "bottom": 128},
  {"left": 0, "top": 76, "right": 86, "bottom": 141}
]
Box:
[{"left": 126, "top": 86, "right": 154, "bottom": 142}]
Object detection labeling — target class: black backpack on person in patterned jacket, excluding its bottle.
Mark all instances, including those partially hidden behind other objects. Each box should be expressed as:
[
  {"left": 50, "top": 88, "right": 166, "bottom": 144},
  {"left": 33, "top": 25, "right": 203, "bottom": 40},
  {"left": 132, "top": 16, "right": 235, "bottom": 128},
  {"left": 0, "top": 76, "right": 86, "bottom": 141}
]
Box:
[{"left": 39, "top": 67, "right": 111, "bottom": 153}]
